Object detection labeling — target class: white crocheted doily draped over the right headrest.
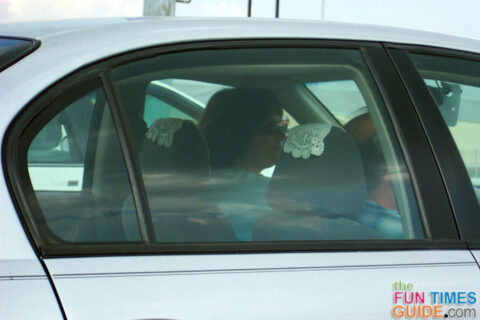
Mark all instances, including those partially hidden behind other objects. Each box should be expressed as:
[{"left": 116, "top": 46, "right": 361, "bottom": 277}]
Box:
[{"left": 283, "top": 123, "right": 332, "bottom": 159}]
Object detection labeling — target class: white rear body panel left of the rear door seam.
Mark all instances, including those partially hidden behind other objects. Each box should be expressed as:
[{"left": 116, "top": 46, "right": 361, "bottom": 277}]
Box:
[{"left": 0, "top": 165, "right": 59, "bottom": 319}]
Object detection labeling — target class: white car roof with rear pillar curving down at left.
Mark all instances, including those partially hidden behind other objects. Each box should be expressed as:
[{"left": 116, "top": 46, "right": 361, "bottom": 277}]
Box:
[{"left": 0, "top": 17, "right": 480, "bottom": 132}]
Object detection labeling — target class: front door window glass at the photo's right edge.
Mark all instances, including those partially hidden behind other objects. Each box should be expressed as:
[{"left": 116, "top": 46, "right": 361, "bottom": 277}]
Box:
[{"left": 410, "top": 54, "right": 480, "bottom": 199}]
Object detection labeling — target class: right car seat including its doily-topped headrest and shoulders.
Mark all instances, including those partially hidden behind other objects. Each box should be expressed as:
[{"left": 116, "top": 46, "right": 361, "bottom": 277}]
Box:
[{"left": 253, "top": 124, "right": 378, "bottom": 241}]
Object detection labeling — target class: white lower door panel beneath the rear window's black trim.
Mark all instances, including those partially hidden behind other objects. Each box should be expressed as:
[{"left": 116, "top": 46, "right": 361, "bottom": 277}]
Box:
[{"left": 46, "top": 250, "right": 480, "bottom": 319}]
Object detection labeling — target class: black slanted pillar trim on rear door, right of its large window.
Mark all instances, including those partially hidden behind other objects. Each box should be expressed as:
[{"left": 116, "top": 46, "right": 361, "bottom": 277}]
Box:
[{"left": 365, "top": 48, "right": 458, "bottom": 239}]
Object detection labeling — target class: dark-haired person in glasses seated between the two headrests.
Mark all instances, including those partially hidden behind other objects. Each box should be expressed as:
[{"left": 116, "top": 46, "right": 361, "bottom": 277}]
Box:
[{"left": 198, "top": 88, "right": 286, "bottom": 241}]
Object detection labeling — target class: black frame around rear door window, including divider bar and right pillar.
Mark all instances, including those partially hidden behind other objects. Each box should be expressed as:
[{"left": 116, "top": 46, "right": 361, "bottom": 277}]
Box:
[{"left": 2, "top": 39, "right": 465, "bottom": 257}]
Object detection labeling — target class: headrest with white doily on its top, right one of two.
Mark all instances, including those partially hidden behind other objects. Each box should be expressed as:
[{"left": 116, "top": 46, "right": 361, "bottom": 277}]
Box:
[{"left": 267, "top": 124, "right": 366, "bottom": 214}]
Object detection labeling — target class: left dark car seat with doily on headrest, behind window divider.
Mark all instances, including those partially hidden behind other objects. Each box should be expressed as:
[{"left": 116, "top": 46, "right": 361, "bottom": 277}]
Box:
[{"left": 123, "top": 118, "right": 235, "bottom": 242}]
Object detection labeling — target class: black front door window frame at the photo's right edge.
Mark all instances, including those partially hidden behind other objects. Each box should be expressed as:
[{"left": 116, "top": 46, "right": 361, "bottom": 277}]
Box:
[{"left": 386, "top": 43, "right": 480, "bottom": 242}]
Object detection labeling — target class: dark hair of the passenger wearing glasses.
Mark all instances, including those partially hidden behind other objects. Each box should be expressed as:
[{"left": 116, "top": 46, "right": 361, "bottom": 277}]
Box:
[{"left": 198, "top": 88, "right": 282, "bottom": 169}]
